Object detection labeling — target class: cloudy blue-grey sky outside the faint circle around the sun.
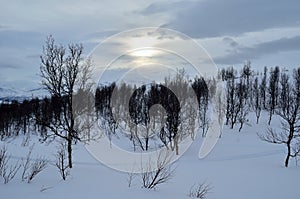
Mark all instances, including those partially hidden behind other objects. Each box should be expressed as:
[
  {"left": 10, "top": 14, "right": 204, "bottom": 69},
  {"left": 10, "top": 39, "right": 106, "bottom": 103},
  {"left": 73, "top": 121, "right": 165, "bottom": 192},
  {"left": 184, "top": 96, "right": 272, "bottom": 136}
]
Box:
[{"left": 0, "top": 0, "right": 300, "bottom": 89}]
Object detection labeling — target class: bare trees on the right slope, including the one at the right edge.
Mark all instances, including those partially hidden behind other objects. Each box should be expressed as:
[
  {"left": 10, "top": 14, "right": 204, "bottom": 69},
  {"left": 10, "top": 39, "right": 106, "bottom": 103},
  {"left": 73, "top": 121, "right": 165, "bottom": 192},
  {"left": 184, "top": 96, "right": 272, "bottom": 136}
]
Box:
[{"left": 220, "top": 62, "right": 300, "bottom": 167}]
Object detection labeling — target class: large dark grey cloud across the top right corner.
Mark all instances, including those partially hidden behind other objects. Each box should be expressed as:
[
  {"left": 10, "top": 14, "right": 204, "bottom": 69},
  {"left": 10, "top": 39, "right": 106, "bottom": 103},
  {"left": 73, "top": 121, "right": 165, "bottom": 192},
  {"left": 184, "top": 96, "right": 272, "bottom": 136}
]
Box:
[{"left": 141, "top": 0, "right": 300, "bottom": 38}]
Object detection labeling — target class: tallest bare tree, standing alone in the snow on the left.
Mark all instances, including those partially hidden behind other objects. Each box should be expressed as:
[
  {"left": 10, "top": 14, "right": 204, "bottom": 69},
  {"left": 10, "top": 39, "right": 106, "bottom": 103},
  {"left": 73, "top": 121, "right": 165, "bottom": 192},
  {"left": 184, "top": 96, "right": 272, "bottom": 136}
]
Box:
[{"left": 40, "top": 36, "right": 83, "bottom": 168}]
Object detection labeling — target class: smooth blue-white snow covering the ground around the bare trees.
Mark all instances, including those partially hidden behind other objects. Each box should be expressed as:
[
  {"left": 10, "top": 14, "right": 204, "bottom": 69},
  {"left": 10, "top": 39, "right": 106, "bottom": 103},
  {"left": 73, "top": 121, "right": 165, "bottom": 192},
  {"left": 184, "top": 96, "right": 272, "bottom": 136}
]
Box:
[{"left": 0, "top": 113, "right": 300, "bottom": 199}]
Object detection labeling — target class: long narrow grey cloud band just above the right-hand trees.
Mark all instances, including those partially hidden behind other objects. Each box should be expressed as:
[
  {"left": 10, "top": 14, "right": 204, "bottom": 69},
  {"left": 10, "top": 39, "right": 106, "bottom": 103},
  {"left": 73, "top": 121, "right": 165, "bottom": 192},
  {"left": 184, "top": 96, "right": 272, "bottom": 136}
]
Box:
[{"left": 214, "top": 36, "right": 300, "bottom": 65}]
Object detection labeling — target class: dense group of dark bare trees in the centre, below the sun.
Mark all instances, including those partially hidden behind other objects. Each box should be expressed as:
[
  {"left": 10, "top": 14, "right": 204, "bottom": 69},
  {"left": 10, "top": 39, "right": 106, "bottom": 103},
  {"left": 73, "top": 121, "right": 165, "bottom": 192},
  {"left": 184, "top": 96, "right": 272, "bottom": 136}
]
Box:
[{"left": 95, "top": 71, "right": 209, "bottom": 154}]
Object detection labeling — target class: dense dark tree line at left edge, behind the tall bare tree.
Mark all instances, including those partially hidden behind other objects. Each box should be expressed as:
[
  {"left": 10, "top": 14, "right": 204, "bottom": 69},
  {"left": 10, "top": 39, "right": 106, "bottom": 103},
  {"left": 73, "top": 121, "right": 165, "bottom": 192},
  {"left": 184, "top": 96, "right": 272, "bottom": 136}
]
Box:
[{"left": 0, "top": 97, "right": 73, "bottom": 140}]
